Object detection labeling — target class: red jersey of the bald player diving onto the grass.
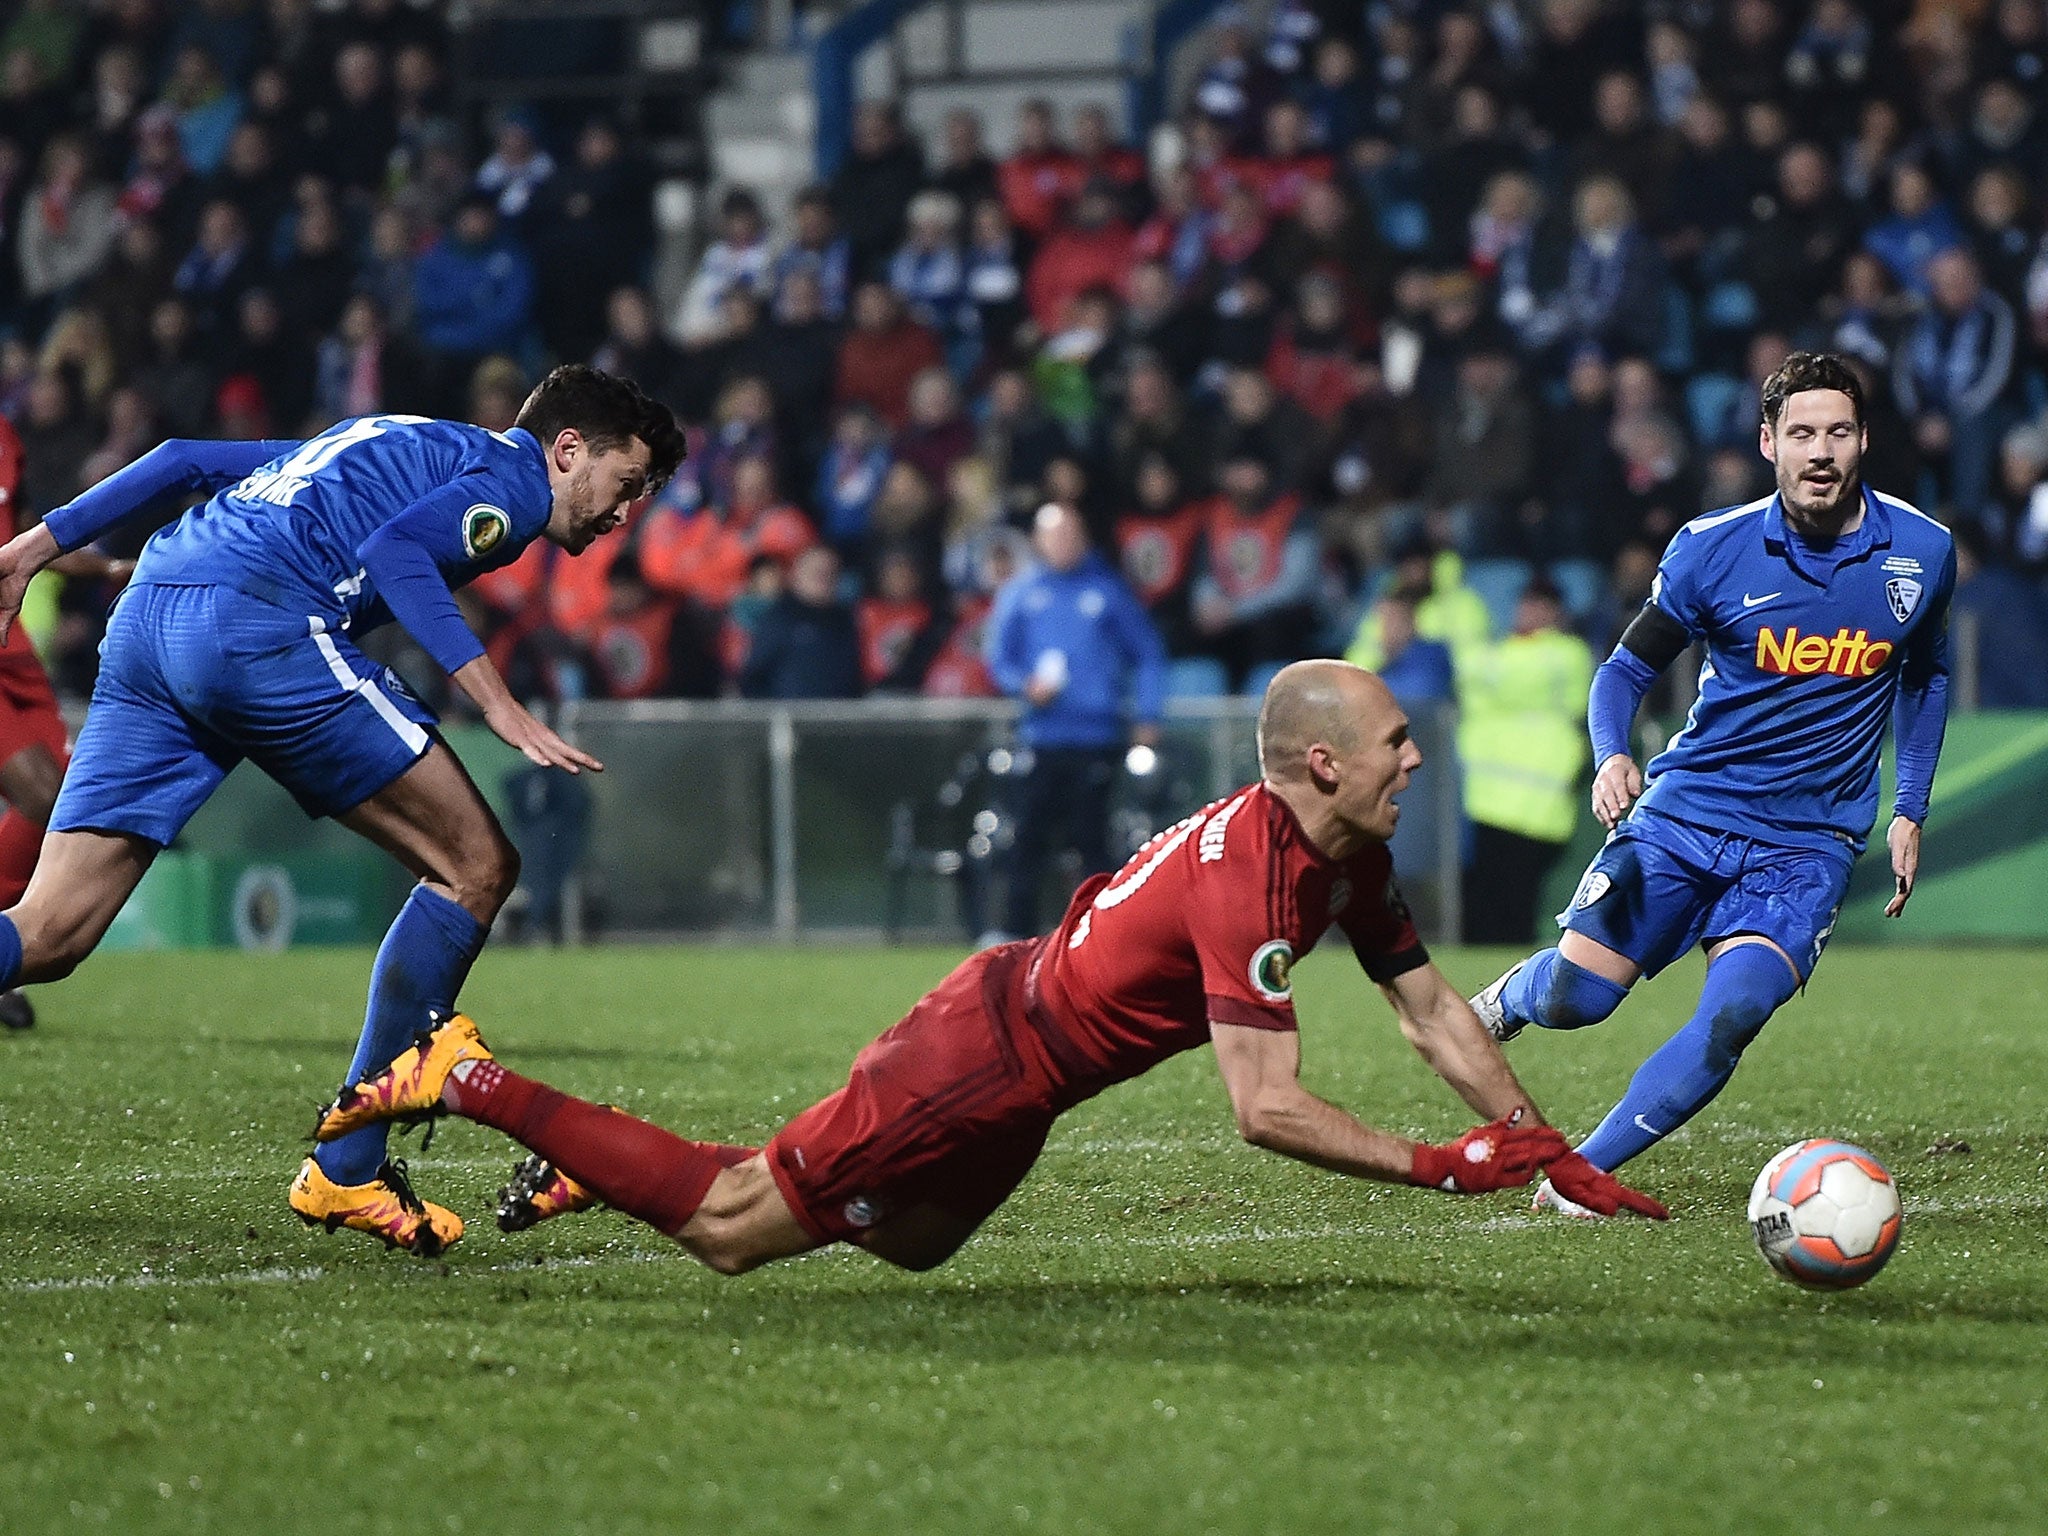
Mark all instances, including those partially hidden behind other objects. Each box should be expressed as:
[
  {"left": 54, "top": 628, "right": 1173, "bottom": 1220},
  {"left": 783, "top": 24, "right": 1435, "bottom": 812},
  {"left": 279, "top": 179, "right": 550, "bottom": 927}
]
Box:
[{"left": 1026, "top": 784, "right": 1430, "bottom": 1102}]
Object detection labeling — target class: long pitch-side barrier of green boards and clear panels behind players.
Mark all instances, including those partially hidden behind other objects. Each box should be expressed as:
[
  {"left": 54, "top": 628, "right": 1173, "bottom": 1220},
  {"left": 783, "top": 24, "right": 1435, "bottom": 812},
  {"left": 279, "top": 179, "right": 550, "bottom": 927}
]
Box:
[{"left": 79, "top": 698, "right": 2048, "bottom": 948}]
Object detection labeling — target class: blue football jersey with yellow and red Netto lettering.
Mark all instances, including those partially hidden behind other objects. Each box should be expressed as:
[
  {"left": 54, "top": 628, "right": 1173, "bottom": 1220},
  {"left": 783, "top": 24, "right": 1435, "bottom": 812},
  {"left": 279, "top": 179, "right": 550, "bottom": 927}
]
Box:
[{"left": 1642, "top": 487, "right": 1956, "bottom": 850}]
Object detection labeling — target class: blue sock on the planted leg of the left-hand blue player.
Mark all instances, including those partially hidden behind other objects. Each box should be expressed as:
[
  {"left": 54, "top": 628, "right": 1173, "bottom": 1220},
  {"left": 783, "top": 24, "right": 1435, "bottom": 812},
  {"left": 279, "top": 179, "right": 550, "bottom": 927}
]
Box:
[{"left": 313, "top": 885, "right": 485, "bottom": 1184}]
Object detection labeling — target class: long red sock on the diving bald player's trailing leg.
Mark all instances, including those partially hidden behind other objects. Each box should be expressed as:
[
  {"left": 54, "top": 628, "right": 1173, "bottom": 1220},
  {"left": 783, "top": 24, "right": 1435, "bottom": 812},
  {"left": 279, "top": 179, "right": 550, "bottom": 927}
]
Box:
[{"left": 442, "top": 1061, "right": 756, "bottom": 1237}]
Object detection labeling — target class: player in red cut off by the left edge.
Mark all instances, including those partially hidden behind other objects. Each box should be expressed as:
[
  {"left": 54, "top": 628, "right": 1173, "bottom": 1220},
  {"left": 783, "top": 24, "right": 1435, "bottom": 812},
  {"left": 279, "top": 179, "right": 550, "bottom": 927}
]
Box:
[{"left": 0, "top": 416, "right": 131, "bottom": 1030}]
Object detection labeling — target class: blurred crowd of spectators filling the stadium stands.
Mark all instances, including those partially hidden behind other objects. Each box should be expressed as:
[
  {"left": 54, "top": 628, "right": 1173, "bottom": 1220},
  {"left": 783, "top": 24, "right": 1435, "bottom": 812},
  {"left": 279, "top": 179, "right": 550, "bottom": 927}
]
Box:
[{"left": 0, "top": 0, "right": 2048, "bottom": 720}]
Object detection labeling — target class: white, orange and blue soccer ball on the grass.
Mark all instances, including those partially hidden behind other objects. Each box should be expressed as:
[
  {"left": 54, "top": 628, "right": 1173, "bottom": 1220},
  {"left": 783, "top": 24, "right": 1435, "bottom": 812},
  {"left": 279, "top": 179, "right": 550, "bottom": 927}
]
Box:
[{"left": 1749, "top": 1139, "right": 1903, "bottom": 1290}]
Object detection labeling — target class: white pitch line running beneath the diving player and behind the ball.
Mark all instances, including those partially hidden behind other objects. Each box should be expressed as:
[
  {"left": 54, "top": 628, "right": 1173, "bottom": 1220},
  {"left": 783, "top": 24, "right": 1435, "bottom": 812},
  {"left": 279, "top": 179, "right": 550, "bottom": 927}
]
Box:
[{"left": 0, "top": 1194, "right": 2048, "bottom": 1296}]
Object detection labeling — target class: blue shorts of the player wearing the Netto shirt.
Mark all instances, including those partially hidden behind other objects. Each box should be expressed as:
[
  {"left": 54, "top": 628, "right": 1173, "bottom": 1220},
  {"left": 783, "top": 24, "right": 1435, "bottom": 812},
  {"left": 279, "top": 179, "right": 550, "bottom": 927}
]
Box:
[{"left": 1556, "top": 809, "right": 1855, "bottom": 981}]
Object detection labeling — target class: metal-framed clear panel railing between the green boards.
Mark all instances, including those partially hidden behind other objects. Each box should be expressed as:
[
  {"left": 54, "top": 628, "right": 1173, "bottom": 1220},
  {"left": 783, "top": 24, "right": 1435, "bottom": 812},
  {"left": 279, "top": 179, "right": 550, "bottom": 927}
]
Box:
[{"left": 561, "top": 698, "right": 1462, "bottom": 940}]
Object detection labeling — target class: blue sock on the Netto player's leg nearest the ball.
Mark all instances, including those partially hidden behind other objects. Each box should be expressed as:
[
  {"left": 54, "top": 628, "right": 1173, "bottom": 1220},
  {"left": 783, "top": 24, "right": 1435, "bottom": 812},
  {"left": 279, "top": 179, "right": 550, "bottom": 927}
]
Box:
[{"left": 1572, "top": 944, "right": 1800, "bottom": 1171}]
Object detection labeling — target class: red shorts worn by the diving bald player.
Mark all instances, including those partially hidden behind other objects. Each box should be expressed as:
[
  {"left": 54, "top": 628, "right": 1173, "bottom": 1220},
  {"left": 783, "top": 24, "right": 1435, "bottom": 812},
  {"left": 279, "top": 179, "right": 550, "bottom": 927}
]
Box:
[{"left": 766, "top": 940, "right": 1059, "bottom": 1243}]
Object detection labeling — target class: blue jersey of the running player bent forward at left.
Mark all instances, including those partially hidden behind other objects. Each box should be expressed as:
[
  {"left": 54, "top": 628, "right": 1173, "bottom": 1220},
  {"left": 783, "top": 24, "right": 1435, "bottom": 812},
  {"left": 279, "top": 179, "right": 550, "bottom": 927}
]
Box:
[{"left": 135, "top": 416, "right": 553, "bottom": 633}]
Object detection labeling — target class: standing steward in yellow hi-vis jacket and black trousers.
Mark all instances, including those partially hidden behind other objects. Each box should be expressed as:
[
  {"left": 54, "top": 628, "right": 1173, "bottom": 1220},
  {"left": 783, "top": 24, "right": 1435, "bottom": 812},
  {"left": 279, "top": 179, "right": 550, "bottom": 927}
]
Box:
[{"left": 1458, "top": 580, "right": 1593, "bottom": 944}]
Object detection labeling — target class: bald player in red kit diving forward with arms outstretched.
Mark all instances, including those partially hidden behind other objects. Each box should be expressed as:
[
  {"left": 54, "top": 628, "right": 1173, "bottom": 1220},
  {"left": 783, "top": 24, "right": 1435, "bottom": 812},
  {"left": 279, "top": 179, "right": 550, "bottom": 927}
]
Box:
[{"left": 315, "top": 662, "right": 1665, "bottom": 1274}]
